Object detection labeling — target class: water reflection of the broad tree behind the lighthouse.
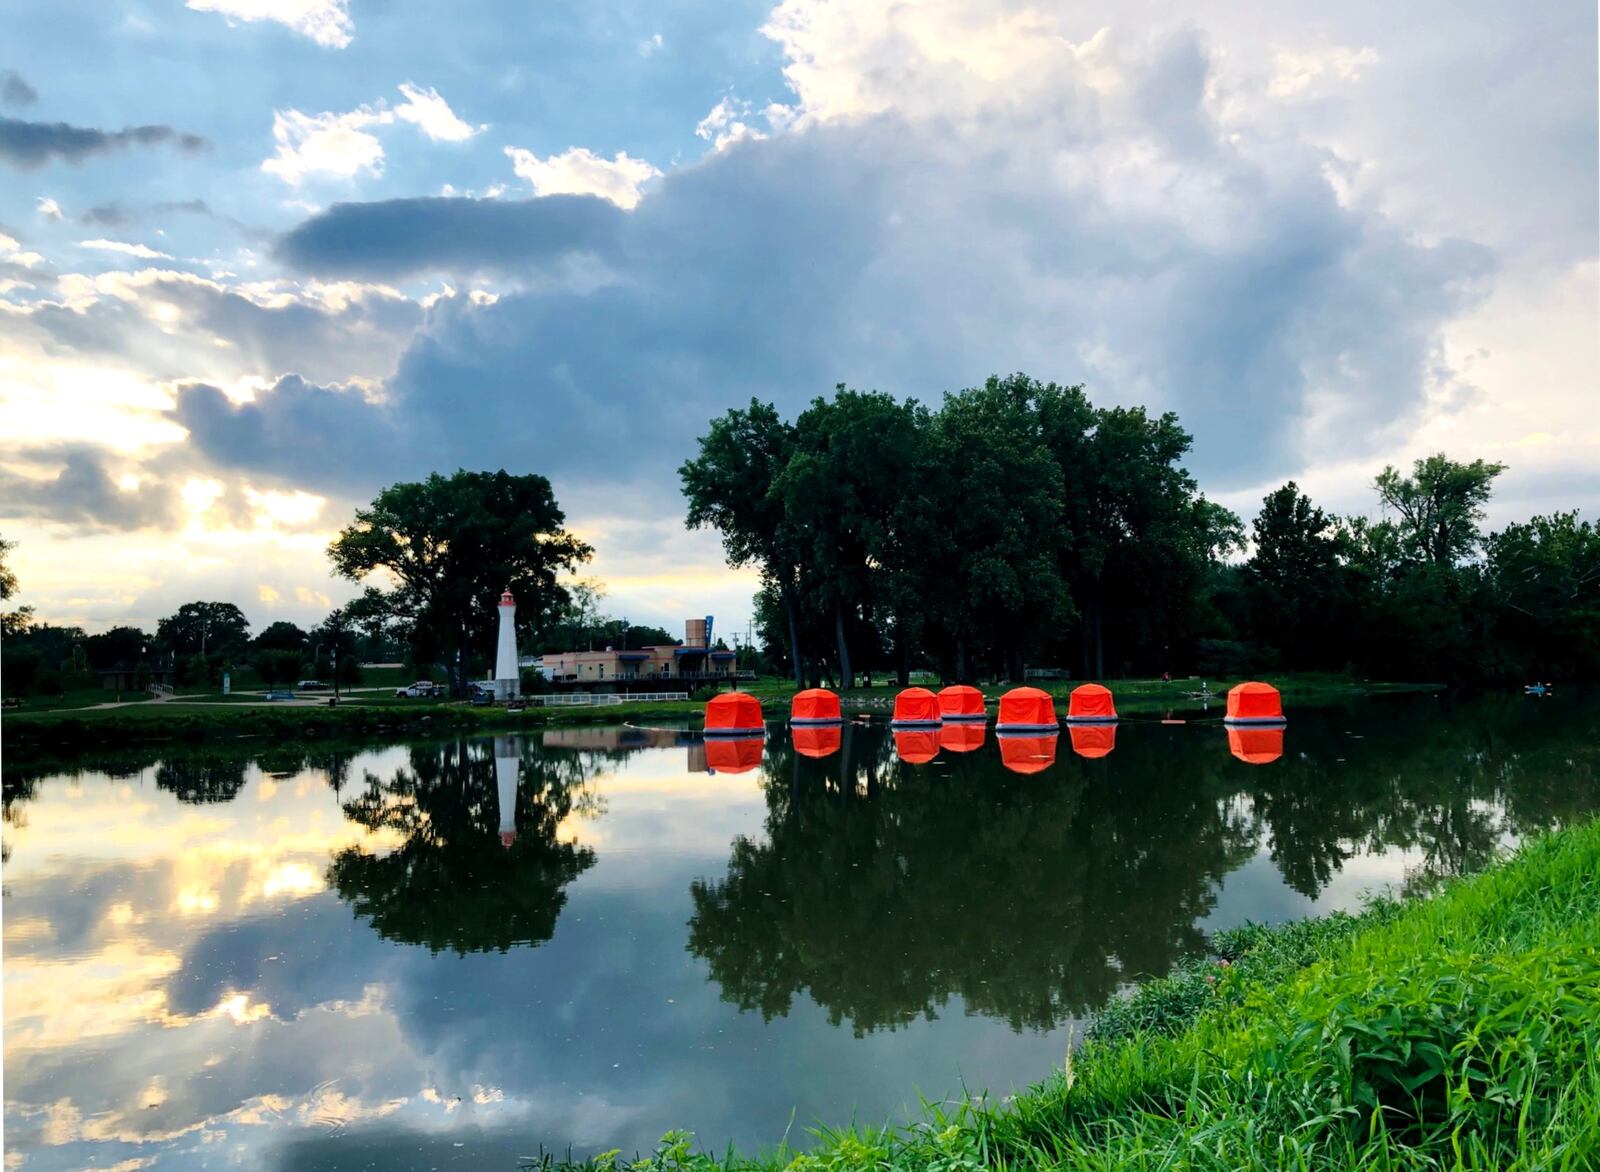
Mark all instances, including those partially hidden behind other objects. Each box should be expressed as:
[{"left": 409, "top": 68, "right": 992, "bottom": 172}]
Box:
[{"left": 328, "top": 737, "right": 594, "bottom": 956}]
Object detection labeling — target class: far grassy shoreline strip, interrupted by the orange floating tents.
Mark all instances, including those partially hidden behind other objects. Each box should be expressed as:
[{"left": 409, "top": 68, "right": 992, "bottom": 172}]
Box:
[{"left": 0, "top": 674, "right": 1440, "bottom": 753}]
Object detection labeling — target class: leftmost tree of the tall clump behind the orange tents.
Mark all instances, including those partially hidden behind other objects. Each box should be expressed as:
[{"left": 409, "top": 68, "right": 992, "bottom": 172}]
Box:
[{"left": 678, "top": 399, "right": 805, "bottom": 687}]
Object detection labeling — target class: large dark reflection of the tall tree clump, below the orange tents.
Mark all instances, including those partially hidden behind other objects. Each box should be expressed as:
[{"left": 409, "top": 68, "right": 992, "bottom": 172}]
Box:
[{"left": 690, "top": 725, "right": 1256, "bottom": 1033}]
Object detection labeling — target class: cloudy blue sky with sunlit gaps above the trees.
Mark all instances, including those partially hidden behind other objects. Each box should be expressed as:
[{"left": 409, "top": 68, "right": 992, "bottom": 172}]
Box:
[{"left": 0, "top": 0, "right": 1600, "bottom": 631}]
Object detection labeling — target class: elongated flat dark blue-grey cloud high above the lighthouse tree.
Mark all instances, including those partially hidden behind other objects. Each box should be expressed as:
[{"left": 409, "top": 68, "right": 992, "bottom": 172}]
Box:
[{"left": 275, "top": 195, "right": 627, "bottom": 280}]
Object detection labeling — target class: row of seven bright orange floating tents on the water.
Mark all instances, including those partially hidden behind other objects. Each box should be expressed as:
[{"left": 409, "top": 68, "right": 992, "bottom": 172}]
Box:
[{"left": 706, "top": 680, "right": 1285, "bottom": 737}]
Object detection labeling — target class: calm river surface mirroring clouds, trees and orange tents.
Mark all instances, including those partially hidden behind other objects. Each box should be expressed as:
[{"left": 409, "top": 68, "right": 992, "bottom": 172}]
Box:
[{"left": 3, "top": 695, "right": 1600, "bottom": 1169}]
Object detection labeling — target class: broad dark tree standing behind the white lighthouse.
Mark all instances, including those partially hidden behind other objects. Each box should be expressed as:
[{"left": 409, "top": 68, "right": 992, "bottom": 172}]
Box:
[{"left": 328, "top": 471, "right": 594, "bottom": 695}]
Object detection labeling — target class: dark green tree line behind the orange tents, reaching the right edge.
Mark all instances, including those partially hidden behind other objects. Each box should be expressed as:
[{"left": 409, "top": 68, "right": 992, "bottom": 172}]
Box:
[{"left": 680, "top": 375, "right": 1600, "bottom": 687}]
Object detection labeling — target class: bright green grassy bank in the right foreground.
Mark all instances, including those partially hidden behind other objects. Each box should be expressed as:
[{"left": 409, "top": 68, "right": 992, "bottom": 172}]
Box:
[{"left": 540, "top": 823, "right": 1600, "bottom": 1172}]
